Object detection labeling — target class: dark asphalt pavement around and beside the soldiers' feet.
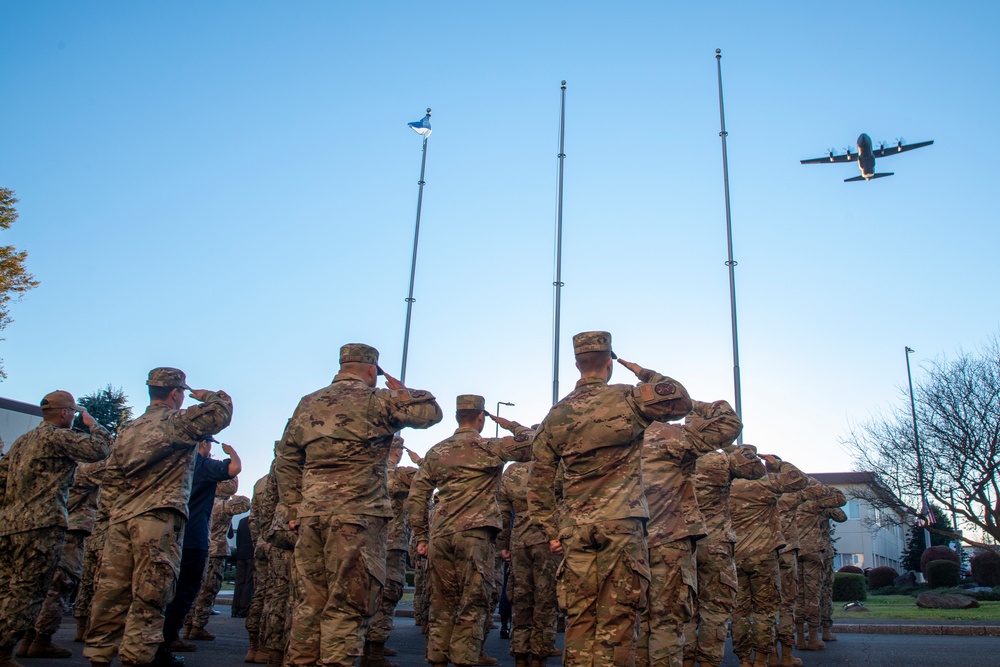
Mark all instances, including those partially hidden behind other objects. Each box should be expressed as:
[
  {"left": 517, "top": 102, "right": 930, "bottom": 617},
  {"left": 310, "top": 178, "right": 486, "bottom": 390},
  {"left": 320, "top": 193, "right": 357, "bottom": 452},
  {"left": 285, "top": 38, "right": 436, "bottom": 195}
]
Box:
[{"left": 18, "top": 606, "right": 1000, "bottom": 667}]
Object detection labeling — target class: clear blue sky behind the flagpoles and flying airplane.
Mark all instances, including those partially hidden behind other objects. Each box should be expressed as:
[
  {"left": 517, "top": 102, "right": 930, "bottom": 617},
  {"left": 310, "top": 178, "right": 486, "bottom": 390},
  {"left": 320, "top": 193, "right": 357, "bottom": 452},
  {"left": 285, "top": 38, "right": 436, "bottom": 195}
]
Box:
[{"left": 0, "top": 1, "right": 1000, "bottom": 490}]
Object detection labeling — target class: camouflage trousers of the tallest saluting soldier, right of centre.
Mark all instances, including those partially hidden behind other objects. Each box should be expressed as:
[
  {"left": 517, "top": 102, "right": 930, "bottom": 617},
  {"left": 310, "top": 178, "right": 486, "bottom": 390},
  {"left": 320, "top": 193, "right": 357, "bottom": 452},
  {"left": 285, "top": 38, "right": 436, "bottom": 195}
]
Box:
[{"left": 556, "top": 519, "right": 650, "bottom": 667}]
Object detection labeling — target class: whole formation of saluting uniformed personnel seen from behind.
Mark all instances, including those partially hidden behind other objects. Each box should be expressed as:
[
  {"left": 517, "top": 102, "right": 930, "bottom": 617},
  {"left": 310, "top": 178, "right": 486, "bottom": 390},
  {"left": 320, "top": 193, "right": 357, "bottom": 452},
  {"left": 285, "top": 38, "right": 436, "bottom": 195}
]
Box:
[{"left": 0, "top": 331, "right": 846, "bottom": 667}]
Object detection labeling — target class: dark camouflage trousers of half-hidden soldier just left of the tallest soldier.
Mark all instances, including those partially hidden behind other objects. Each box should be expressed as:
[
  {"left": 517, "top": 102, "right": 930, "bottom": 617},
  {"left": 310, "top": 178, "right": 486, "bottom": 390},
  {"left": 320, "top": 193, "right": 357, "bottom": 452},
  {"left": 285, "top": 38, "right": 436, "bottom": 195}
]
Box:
[{"left": 507, "top": 542, "right": 559, "bottom": 656}]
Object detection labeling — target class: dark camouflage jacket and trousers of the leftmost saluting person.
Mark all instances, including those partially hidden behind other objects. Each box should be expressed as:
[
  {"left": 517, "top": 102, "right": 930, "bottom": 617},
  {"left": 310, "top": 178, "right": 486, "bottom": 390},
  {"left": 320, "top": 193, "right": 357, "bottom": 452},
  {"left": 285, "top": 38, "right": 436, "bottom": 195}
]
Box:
[{"left": 0, "top": 421, "right": 111, "bottom": 649}]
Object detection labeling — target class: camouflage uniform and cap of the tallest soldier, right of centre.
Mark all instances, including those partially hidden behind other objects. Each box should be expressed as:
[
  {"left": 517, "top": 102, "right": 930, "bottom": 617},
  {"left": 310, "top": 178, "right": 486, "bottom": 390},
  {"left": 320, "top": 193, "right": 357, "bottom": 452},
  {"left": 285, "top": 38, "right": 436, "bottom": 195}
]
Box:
[{"left": 528, "top": 332, "right": 691, "bottom": 666}]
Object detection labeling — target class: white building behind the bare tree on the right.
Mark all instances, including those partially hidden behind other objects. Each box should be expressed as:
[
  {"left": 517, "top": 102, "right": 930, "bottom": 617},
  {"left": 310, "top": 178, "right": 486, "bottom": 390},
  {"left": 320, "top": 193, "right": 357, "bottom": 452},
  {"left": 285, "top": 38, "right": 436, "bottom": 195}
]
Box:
[{"left": 811, "top": 472, "right": 912, "bottom": 572}]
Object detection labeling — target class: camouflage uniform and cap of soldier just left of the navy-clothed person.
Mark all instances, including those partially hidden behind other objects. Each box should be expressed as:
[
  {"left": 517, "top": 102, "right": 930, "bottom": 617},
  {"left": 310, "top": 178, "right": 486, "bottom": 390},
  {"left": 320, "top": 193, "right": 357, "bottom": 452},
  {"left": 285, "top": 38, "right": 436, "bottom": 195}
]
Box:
[{"left": 83, "top": 368, "right": 233, "bottom": 664}]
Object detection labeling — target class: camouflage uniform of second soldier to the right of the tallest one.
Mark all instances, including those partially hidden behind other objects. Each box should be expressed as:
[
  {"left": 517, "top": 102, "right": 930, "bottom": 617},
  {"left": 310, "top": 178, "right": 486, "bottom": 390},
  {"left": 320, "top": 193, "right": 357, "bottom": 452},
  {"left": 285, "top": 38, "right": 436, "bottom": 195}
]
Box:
[{"left": 684, "top": 446, "right": 764, "bottom": 667}]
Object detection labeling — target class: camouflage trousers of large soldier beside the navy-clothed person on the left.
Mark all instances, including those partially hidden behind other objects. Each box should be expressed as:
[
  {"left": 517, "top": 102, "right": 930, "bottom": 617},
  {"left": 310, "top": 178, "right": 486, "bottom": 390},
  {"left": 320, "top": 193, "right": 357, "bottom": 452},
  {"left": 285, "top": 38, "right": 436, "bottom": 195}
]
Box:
[{"left": 83, "top": 510, "right": 185, "bottom": 665}]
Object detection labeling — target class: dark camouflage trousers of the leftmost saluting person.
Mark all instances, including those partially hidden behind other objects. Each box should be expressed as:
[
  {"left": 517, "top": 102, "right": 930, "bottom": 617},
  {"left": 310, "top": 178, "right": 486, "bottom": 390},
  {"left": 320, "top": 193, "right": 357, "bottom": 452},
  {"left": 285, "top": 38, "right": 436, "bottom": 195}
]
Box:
[{"left": 0, "top": 526, "right": 66, "bottom": 648}]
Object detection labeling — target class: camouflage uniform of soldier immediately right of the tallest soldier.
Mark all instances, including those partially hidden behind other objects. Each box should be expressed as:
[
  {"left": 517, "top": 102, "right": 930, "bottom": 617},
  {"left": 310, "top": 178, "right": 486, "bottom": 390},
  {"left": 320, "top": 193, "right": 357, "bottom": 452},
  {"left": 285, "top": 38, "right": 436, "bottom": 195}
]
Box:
[{"left": 637, "top": 401, "right": 743, "bottom": 667}]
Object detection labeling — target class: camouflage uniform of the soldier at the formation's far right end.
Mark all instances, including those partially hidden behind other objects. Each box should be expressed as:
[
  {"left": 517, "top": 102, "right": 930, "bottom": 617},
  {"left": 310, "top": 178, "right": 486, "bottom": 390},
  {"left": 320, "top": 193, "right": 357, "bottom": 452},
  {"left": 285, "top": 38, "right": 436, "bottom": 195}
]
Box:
[{"left": 795, "top": 480, "right": 847, "bottom": 629}]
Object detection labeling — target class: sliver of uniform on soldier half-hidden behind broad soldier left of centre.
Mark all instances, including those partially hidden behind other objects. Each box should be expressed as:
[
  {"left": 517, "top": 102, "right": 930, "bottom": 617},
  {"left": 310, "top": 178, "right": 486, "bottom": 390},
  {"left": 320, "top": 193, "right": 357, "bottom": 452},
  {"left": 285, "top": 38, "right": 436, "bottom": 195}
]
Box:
[{"left": 365, "top": 465, "right": 417, "bottom": 644}]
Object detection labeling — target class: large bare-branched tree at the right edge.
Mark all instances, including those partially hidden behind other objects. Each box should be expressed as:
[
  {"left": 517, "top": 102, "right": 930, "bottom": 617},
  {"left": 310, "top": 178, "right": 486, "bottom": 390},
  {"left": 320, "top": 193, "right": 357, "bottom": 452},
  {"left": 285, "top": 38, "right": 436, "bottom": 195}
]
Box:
[{"left": 842, "top": 336, "right": 1000, "bottom": 549}]
